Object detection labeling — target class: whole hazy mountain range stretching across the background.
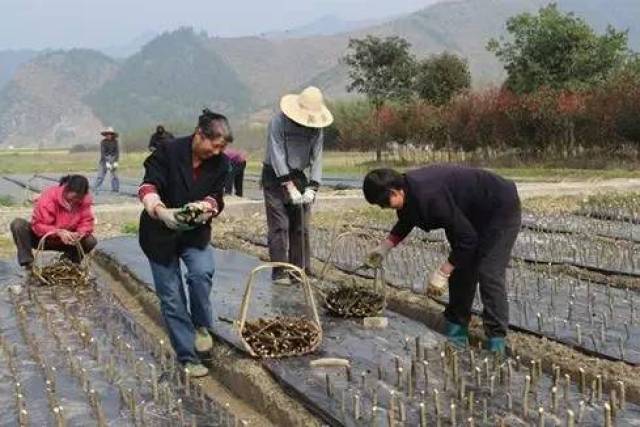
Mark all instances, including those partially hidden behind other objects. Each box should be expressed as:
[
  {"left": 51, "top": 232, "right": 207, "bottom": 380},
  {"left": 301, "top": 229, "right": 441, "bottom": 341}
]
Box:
[{"left": 0, "top": 0, "right": 640, "bottom": 146}]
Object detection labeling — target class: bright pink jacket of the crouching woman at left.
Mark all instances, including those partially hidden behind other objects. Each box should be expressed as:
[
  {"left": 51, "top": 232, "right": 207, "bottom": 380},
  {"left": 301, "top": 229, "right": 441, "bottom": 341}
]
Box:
[{"left": 31, "top": 185, "right": 94, "bottom": 237}]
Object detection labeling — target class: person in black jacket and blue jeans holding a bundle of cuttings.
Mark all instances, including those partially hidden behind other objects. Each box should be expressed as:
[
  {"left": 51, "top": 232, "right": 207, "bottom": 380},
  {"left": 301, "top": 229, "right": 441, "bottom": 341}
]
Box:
[{"left": 139, "top": 110, "right": 233, "bottom": 377}]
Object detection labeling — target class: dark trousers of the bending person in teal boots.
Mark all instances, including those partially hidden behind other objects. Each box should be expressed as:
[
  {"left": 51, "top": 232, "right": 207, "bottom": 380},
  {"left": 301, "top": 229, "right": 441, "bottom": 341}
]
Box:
[{"left": 444, "top": 209, "right": 521, "bottom": 337}]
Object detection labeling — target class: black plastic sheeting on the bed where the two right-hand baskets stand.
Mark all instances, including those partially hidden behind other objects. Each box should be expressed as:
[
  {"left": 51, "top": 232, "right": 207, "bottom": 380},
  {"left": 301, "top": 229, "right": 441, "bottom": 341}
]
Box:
[{"left": 94, "top": 238, "right": 640, "bottom": 426}]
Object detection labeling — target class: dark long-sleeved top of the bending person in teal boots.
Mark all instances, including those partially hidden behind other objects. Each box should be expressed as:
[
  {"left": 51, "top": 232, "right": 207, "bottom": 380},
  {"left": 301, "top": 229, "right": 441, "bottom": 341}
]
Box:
[{"left": 390, "top": 165, "right": 520, "bottom": 267}]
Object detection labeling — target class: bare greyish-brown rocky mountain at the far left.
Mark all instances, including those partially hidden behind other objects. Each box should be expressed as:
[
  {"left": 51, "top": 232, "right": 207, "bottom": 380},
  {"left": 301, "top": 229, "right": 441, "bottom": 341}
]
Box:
[{"left": 0, "top": 49, "right": 117, "bottom": 147}]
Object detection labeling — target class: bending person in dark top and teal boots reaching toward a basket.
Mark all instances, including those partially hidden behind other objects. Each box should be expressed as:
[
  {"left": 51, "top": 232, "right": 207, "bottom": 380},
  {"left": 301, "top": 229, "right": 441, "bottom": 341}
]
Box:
[{"left": 363, "top": 165, "right": 521, "bottom": 353}]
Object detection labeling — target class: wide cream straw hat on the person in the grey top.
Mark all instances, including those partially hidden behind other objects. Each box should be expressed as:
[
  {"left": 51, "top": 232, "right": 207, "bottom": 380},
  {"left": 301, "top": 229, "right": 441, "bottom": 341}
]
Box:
[{"left": 280, "top": 86, "right": 333, "bottom": 128}]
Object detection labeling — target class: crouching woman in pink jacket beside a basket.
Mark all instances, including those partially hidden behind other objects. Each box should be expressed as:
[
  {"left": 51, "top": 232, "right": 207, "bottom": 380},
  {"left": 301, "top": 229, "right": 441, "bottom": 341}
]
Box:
[{"left": 11, "top": 175, "right": 98, "bottom": 269}]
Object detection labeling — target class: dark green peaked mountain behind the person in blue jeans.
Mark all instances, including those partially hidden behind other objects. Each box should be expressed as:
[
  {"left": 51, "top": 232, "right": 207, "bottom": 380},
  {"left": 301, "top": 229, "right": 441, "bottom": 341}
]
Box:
[{"left": 85, "top": 28, "right": 250, "bottom": 129}]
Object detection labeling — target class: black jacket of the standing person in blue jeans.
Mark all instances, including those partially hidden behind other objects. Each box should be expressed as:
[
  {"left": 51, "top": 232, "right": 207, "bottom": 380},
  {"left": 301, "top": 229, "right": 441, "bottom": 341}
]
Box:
[{"left": 139, "top": 136, "right": 229, "bottom": 264}]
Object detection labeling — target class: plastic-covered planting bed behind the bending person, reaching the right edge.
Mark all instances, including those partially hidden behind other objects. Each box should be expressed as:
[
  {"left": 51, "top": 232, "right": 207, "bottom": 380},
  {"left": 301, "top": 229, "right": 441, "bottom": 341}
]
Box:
[{"left": 234, "top": 229, "right": 640, "bottom": 365}]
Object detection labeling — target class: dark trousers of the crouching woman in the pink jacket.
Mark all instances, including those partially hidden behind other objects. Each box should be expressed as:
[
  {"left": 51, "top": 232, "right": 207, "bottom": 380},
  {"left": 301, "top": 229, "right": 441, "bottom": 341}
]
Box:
[{"left": 10, "top": 218, "right": 98, "bottom": 266}]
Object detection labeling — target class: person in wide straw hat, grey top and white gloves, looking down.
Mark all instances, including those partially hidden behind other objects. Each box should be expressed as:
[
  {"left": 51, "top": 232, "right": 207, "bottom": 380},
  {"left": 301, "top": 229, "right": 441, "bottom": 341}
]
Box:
[{"left": 261, "top": 86, "right": 333, "bottom": 284}]
